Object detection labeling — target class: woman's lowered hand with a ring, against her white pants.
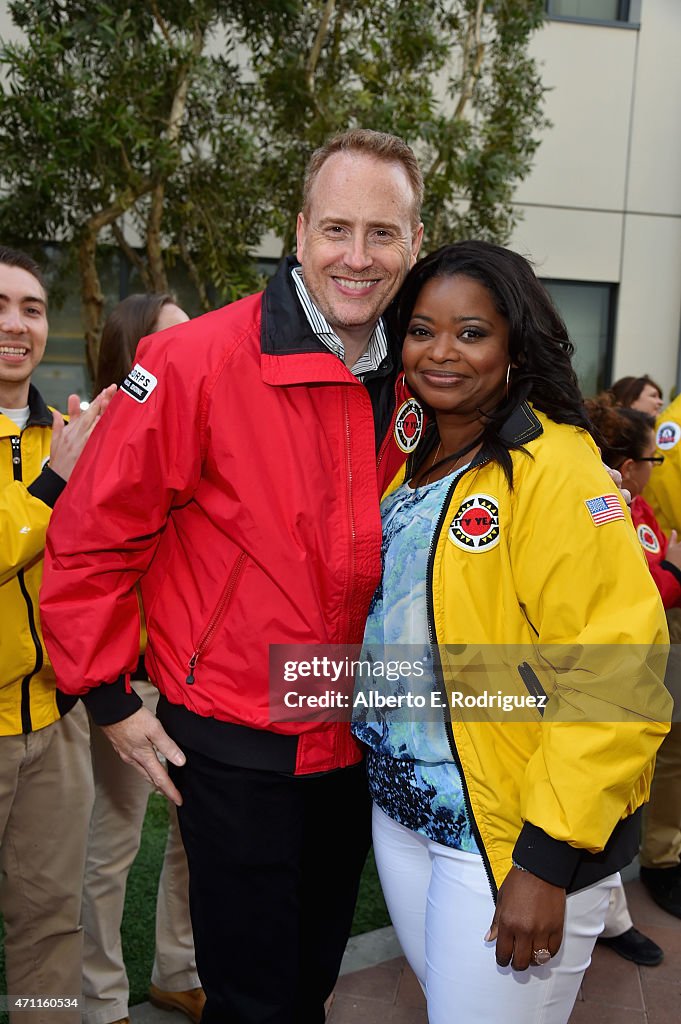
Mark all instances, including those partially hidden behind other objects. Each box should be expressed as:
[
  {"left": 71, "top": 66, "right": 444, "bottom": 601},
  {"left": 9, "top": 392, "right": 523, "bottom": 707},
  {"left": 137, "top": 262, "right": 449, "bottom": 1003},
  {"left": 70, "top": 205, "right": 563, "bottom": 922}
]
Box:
[{"left": 485, "top": 867, "right": 565, "bottom": 971}]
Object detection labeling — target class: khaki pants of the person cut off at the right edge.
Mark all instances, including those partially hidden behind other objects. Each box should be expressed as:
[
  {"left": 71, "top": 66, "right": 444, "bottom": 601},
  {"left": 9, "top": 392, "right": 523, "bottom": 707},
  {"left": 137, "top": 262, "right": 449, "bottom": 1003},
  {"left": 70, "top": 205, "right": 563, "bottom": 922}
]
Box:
[{"left": 641, "top": 608, "right": 681, "bottom": 867}]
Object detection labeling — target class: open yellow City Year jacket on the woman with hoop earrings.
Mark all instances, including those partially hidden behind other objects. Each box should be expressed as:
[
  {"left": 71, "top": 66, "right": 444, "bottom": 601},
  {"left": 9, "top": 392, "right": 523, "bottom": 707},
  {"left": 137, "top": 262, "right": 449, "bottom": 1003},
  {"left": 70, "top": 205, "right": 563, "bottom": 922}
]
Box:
[{"left": 382, "top": 404, "right": 671, "bottom": 891}]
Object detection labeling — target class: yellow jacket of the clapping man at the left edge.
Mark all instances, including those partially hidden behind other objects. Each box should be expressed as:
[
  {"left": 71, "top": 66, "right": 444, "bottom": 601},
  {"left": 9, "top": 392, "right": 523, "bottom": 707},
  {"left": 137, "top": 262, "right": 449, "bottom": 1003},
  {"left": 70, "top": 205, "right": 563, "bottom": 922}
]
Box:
[{"left": 0, "top": 386, "right": 72, "bottom": 736}]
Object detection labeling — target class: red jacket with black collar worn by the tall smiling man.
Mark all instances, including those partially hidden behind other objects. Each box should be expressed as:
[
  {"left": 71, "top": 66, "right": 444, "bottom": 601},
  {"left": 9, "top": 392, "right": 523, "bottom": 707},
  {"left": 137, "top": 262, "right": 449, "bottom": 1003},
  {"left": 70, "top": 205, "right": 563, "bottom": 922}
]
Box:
[{"left": 41, "top": 263, "right": 418, "bottom": 773}]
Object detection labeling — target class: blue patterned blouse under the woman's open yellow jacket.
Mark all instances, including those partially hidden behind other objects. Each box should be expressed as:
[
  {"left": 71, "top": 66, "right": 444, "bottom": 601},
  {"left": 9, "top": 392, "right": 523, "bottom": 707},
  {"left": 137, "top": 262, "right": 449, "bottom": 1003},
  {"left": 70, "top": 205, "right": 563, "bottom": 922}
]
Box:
[{"left": 352, "top": 467, "right": 478, "bottom": 853}]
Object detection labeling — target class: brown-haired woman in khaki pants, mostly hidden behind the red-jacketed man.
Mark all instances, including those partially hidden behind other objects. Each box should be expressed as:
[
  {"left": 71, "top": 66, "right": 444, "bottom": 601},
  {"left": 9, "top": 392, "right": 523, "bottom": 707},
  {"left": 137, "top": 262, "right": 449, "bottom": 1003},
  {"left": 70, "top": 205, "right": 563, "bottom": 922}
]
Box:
[{"left": 83, "top": 294, "right": 205, "bottom": 1024}]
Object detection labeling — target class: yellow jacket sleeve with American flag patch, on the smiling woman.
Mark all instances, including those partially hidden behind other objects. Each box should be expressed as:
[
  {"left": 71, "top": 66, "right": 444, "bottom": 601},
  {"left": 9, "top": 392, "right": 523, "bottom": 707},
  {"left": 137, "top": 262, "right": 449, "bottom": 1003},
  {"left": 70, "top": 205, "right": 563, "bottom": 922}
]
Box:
[{"left": 511, "top": 423, "right": 671, "bottom": 852}]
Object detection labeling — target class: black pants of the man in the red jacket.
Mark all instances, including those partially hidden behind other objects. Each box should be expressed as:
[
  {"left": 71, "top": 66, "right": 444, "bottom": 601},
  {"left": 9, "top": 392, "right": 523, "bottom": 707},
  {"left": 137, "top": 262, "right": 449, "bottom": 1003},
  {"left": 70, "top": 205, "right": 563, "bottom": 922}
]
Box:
[{"left": 168, "top": 751, "right": 371, "bottom": 1024}]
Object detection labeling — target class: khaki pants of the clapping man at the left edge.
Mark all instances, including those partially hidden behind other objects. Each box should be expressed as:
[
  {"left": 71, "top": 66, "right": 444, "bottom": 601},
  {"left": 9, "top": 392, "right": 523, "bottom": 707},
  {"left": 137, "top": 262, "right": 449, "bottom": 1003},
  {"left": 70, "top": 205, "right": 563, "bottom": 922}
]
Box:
[{"left": 0, "top": 701, "right": 92, "bottom": 1024}]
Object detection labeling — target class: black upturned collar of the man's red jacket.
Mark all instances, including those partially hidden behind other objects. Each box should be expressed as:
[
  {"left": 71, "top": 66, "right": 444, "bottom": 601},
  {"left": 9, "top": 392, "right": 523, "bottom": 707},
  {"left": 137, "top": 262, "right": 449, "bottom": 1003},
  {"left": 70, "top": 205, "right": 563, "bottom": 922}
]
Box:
[{"left": 260, "top": 256, "right": 400, "bottom": 451}]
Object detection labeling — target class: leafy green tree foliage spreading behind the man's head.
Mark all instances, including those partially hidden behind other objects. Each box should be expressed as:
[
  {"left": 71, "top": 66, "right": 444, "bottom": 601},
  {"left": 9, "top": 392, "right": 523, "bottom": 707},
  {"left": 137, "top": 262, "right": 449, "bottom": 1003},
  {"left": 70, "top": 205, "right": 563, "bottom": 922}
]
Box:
[{"left": 0, "top": 0, "right": 546, "bottom": 367}]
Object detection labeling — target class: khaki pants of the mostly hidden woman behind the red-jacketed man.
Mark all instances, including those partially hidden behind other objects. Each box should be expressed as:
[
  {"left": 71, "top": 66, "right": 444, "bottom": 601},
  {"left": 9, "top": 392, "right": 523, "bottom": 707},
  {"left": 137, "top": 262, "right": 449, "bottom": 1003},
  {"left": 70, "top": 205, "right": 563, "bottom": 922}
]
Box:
[{"left": 83, "top": 682, "right": 199, "bottom": 1024}]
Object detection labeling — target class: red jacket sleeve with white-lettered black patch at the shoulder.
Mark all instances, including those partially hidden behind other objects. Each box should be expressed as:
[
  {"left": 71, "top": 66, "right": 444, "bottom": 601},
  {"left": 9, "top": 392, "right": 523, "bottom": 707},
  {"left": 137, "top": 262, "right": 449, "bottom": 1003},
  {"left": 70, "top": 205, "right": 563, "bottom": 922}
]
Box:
[{"left": 41, "top": 321, "right": 205, "bottom": 693}]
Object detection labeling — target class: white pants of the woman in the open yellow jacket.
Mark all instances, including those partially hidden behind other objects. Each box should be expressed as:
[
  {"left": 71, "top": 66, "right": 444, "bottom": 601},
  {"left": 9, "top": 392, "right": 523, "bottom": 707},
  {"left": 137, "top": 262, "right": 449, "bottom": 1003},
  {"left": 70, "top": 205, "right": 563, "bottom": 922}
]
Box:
[{"left": 374, "top": 805, "right": 619, "bottom": 1024}]
